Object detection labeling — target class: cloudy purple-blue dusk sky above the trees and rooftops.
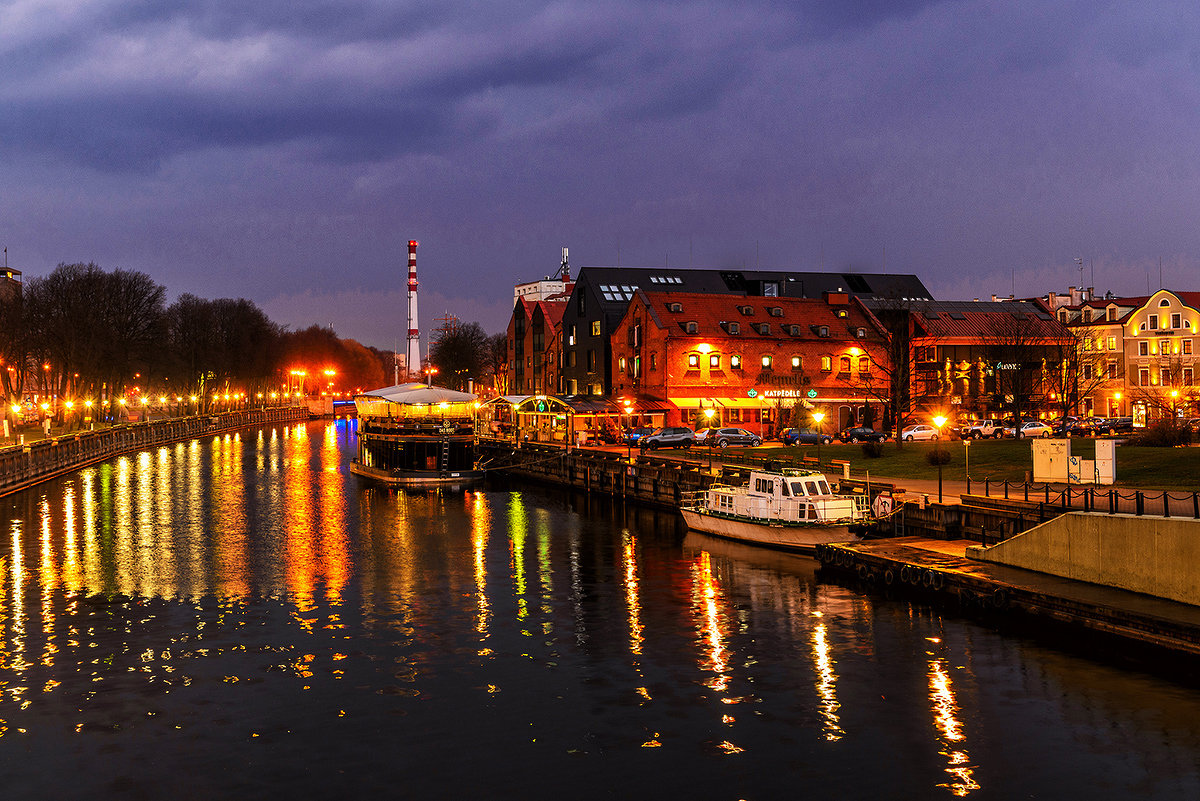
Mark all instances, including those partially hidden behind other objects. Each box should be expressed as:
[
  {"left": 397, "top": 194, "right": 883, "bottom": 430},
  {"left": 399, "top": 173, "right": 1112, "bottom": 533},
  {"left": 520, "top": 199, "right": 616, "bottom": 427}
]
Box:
[{"left": 7, "top": 0, "right": 1200, "bottom": 349}]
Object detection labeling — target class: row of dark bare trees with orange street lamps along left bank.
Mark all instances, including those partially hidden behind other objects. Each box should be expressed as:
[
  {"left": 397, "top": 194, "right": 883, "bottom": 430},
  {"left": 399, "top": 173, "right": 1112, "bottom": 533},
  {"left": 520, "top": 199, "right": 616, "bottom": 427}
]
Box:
[{"left": 0, "top": 263, "right": 432, "bottom": 424}]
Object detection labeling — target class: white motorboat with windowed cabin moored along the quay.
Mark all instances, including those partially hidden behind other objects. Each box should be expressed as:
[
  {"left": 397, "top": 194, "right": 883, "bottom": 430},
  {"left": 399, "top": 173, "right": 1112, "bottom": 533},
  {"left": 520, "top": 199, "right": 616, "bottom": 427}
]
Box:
[{"left": 679, "top": 470, "right": 871, "bottom": 552}]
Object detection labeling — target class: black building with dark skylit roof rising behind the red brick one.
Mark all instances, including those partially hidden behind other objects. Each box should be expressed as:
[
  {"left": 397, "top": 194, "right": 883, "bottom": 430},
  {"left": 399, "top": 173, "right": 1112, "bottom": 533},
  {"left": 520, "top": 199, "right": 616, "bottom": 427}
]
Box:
[{"left": 563, "top": 267, "right": 930, "bottom": 395}]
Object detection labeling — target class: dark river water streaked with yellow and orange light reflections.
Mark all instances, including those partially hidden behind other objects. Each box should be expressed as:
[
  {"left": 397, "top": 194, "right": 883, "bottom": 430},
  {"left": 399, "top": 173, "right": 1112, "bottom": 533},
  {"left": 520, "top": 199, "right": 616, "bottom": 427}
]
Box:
[{"left": 0, "top": 422, "right": 1200, "bottom": 800}]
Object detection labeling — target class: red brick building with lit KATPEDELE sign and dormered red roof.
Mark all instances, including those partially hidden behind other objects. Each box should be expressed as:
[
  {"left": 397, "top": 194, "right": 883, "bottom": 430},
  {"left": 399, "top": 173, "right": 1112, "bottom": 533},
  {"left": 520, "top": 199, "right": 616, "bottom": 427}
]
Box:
[{"left": 612, "top": 290, "right": 887, "bottom": 435}]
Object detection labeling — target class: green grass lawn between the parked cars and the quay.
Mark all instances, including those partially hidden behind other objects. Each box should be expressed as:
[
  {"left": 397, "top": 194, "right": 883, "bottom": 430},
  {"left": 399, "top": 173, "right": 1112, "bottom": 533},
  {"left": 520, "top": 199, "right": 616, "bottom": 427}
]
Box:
[{"left": 694, "top": 439, "right": 1200, "bottom": 490}]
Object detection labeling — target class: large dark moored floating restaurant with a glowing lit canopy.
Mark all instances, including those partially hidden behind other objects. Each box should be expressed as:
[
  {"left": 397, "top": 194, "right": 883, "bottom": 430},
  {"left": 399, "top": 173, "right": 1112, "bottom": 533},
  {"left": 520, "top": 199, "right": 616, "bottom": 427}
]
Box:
[{"left": 350, "top": 384, "right": 484, "bottom": 487}]
